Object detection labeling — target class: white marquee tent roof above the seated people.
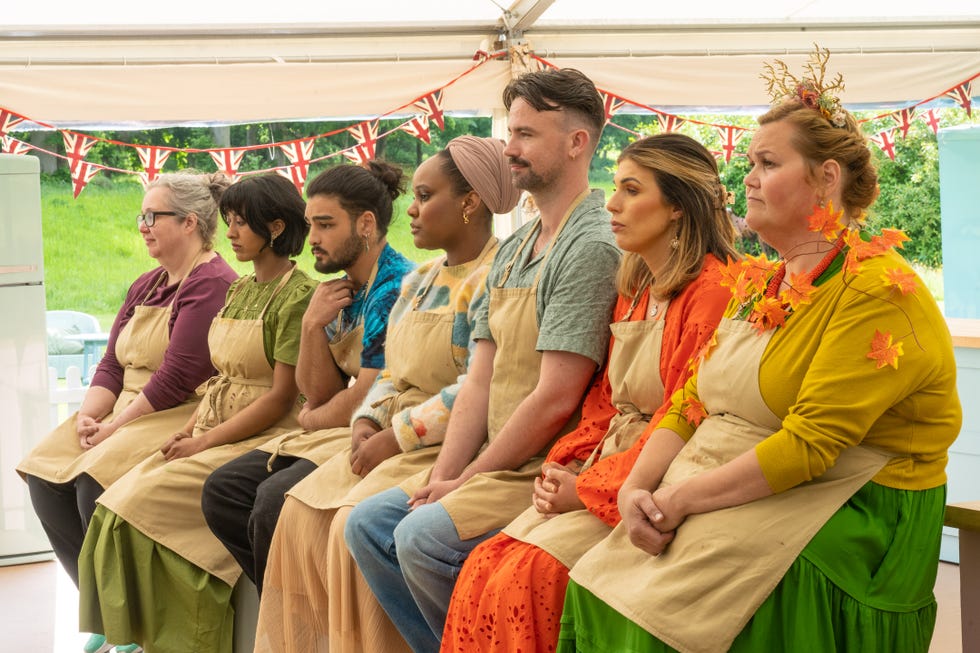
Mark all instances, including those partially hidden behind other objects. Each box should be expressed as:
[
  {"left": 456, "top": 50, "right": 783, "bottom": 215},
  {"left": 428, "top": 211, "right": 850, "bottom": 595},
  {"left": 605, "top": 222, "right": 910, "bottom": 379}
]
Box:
[{"left": 0, "top": 0, "right": 980, "bottom": 127}]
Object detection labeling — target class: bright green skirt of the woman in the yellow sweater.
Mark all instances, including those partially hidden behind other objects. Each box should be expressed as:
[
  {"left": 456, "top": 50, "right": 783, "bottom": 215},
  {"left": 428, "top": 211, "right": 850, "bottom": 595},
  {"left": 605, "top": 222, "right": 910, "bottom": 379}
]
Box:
[{"left": 557, "top": 483, "right": 946, "bottom": 653}]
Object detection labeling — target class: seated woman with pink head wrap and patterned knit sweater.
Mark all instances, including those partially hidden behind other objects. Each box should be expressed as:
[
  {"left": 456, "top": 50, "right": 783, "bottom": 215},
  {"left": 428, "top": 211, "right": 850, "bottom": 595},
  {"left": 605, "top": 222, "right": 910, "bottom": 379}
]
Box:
[{"left": 249, "top": 136, "right": 520, "bottom": 653}]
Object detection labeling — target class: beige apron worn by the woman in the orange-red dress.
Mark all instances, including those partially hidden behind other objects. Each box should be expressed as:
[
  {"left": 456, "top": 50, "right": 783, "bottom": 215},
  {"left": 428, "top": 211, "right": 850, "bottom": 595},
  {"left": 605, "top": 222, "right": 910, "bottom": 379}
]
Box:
[{"left": 504, "top": 306, "right": 664, "bottom": 568}]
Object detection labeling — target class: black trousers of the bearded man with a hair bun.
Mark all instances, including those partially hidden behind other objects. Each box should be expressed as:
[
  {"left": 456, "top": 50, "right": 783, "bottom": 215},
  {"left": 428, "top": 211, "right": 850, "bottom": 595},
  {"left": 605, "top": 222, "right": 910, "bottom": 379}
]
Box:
[{"left": 201, "top": 451, "right": 316, "bottom": 592}]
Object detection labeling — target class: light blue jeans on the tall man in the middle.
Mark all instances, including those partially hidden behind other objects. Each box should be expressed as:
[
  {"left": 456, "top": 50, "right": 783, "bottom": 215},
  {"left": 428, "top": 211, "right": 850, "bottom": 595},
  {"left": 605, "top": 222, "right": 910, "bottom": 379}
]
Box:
[{"left": 344, "top": 488, "right": 499, "bottom": 653}]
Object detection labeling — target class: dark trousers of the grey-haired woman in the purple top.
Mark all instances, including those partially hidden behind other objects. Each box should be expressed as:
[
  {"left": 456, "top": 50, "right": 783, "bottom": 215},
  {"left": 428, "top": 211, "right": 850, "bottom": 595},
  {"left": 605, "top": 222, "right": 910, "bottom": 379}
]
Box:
[{"left": 27, "top": 474, "right": 105, "bottom": 587}]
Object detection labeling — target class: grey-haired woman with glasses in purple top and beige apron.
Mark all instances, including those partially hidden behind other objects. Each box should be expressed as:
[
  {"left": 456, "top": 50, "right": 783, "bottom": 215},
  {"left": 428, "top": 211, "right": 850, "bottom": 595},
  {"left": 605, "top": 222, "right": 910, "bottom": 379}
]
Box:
[{"left": 17, "top": 172, "right": 238, "bottom": 650}]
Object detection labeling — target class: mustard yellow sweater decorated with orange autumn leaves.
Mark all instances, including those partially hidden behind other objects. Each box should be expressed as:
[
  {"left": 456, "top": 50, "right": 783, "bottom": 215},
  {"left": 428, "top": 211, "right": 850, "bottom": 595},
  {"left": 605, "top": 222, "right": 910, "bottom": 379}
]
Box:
[{"left": 660, "top": 247, "right": 962, "bottom": 492}]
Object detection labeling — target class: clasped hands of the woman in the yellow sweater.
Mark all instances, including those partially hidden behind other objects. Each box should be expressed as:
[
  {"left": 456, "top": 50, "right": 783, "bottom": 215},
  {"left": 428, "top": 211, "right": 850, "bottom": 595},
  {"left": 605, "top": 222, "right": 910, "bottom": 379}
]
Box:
[{"left": 619, "top": 486, "right": 686, "bottom": 556}]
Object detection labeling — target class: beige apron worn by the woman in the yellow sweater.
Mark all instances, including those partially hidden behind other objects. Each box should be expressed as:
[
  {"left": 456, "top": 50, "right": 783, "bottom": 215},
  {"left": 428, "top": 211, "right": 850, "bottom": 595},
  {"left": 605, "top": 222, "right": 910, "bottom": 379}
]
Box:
[{"left": 571, "top": 318, "right": 889, "bottom": 653}]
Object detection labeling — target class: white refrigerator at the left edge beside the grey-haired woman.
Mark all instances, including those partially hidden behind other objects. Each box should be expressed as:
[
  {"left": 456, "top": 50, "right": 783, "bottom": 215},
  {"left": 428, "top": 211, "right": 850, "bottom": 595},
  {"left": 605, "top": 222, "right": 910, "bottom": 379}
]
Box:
[{"left": 0, "top": 154, "right": 51, "bottom": 565}]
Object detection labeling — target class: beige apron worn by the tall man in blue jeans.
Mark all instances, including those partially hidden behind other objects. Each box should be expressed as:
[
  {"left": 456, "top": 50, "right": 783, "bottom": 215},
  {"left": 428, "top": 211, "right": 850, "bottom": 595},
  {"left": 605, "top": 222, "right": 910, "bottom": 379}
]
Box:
[{"left": 399, "top": 194, "right": 586, "bottom": 540}]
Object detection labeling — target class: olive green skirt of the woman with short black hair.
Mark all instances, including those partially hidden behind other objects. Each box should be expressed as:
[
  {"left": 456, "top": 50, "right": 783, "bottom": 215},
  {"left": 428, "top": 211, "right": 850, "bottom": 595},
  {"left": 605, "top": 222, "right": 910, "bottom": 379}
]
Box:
[{"left": 78, "top": 505, "right": 235, "bottom": 653}]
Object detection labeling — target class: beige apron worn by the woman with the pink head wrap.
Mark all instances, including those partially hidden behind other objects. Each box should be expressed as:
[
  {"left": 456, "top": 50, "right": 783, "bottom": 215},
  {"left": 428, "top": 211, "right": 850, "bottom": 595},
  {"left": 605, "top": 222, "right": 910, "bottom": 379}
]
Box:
[{"left": 288, "top": 247, "right": 493, "bottom": 510}]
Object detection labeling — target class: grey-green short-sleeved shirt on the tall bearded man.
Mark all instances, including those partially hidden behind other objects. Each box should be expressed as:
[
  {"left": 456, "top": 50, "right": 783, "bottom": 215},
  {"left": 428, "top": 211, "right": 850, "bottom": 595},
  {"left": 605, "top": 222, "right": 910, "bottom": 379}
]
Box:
[{"left": 473, "top": 190, "right": 620, "bottom": 365}]
